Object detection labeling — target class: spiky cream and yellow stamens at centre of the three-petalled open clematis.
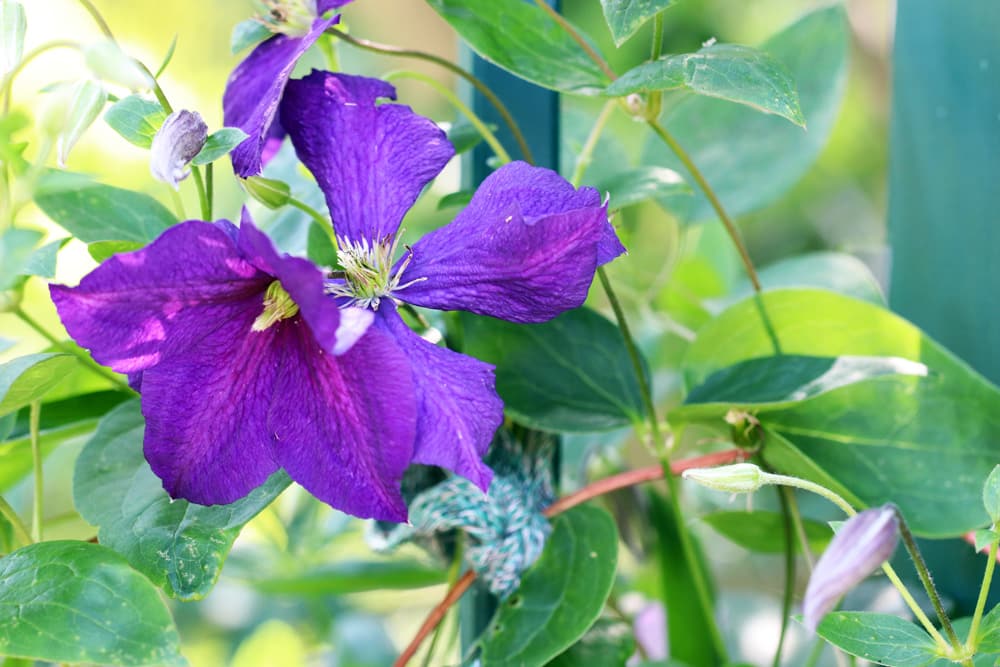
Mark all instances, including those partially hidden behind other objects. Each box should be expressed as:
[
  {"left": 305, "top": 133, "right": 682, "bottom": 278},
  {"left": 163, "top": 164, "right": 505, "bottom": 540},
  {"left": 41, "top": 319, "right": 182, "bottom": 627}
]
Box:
[{"left": 327, "top": 235, "right": 426, "bottom": 310}]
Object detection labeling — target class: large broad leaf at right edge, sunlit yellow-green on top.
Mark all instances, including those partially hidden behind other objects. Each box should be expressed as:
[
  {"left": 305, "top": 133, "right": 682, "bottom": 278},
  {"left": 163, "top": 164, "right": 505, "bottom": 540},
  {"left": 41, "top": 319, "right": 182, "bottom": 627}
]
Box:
[{"left": 683, "top": 289, "right": 1000, "bottom": 537}]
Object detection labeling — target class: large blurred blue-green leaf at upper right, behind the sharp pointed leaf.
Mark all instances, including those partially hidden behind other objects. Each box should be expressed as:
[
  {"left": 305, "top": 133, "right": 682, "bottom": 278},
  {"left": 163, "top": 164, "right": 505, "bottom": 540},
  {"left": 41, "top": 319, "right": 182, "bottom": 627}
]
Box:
[{"left": 644, "top": 5, "right": 849, "bottom": 222}]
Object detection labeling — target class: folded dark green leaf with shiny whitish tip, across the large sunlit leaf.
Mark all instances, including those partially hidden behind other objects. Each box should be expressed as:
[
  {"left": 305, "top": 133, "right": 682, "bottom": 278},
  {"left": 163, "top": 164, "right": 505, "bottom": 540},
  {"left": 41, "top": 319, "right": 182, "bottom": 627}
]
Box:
[{"left": 671, "top": 354, "right": 927, "bottom": 421}]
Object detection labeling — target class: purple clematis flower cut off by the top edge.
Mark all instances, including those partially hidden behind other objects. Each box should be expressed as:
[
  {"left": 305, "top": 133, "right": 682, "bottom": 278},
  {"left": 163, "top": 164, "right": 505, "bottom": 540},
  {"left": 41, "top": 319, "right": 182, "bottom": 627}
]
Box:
[{"left": 222, "top": 0, "right": 351, "bottom": 178}]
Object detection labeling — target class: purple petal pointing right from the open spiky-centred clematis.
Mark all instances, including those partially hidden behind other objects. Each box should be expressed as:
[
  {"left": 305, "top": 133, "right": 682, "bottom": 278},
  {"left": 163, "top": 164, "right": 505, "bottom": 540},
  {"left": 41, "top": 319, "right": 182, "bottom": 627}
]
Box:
[{"left": 397, "top": 163, "right": 624, "bottom": 322}]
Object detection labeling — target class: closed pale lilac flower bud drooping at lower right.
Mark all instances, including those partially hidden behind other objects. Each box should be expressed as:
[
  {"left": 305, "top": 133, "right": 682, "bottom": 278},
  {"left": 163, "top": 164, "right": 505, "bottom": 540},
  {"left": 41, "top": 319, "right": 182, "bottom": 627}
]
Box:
[{"left": 802, "top": 504, "right": 899, "bottom": 630}]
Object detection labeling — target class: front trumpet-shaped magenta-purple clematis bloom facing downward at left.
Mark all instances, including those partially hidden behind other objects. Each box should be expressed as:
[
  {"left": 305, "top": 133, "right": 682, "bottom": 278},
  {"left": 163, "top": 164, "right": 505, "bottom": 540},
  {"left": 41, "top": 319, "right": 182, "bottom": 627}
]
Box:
[{"left": 51, "top": 218, "right": 417, "bottom": 521}]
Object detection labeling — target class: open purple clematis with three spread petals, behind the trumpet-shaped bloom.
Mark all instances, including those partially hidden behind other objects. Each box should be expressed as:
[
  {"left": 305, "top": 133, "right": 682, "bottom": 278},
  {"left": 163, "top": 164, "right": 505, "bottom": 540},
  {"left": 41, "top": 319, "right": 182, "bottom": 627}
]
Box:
[{"left": 280, "top": 71, "right": 625, "bottom": 490}]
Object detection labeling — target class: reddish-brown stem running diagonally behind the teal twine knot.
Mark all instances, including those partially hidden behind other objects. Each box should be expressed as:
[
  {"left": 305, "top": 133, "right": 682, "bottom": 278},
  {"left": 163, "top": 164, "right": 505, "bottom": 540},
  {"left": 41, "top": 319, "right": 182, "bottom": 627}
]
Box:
[{"left": 393, "top": 449, "right": 746, "bottom": 667}]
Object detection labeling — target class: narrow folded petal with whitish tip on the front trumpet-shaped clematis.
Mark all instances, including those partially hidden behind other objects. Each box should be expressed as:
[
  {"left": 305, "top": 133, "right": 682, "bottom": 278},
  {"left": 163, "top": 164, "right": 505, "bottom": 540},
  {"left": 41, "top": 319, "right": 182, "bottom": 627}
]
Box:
[{"left": 239, "top": 208, "right": 373, "bottom": 354}]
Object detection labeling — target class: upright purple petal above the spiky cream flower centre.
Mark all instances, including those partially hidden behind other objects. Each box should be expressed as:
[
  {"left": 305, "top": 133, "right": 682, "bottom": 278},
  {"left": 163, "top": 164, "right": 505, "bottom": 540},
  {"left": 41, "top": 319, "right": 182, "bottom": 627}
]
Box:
[{"left": 281, "top": 71, "right": 455, "bottom": 241}]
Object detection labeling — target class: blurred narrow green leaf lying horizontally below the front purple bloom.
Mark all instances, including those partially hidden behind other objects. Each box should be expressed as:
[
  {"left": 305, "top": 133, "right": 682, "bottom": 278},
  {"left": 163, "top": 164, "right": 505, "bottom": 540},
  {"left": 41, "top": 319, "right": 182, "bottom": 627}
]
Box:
[{"left": 247, "top": 560, "right": 447, "bottom": 597}]
